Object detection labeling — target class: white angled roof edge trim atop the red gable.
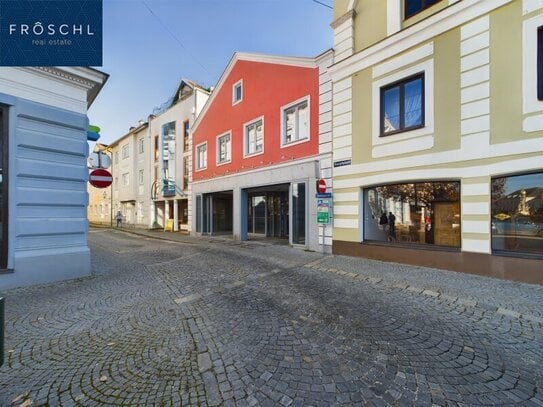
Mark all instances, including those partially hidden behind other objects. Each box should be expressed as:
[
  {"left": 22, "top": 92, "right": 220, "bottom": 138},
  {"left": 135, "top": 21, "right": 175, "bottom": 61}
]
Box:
[{"left": 192, "top": 52, "right": 317, "bottom": 131}]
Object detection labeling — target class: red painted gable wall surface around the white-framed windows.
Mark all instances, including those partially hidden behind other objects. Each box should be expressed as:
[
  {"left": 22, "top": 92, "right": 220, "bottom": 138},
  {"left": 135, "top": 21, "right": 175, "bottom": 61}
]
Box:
[{"left": 192, "top": 60, "right": 319, "bottom": 181}]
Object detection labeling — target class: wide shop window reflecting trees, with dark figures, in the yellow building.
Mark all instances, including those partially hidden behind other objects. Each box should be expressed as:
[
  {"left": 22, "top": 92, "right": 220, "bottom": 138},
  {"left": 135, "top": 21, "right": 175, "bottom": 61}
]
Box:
[{"left": 364, "top": 181, "right": 460, "bottom": 248}]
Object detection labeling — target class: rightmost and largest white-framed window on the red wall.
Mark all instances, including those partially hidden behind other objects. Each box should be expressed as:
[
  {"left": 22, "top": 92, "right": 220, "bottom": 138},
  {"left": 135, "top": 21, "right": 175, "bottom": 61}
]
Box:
[{"left": 281, "top": 96, "right": 310, "bottom": 146}]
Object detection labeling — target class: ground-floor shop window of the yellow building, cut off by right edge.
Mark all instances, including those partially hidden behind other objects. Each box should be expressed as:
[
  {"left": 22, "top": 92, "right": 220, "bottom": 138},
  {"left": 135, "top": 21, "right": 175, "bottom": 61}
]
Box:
[{"left": 491, "top": 172, "right": 543, "bottom": 255}]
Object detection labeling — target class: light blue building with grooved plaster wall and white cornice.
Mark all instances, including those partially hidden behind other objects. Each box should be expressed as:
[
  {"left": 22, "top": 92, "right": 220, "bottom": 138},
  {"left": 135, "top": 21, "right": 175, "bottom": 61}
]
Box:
[{"left": 0, "top": 67, "right": 108, "bottom": 290}]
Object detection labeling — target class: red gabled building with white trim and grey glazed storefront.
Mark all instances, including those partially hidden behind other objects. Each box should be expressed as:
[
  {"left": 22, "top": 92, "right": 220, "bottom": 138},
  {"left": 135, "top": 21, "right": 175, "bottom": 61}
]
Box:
[{"left": 192, "top": 51, "right": 332, "bottom": 250}]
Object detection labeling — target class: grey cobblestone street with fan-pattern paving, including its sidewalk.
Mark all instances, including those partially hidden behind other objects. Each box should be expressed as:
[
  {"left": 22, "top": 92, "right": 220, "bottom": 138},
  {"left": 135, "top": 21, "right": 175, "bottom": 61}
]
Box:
[{"left": 0, "top": 229, "right": 543, "bottom": 407}]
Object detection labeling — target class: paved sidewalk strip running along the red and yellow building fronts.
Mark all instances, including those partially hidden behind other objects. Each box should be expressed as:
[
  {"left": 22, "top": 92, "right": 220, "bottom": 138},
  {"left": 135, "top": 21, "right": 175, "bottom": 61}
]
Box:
[{"left": 105, "top": 228, "right": 543, "bottom": 326}]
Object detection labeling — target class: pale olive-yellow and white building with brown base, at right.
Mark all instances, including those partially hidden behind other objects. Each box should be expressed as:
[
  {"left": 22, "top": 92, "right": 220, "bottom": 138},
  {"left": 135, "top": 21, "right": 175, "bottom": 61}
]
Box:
[{"left": 330, "top": 0, "right": 543, "bottom": 284}]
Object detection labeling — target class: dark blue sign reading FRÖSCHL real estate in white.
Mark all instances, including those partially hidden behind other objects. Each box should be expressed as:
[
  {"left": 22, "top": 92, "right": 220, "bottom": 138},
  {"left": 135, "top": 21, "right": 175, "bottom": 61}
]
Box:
[{"left": 0, "top": 0, "right": 102, "bottom": 66}]
